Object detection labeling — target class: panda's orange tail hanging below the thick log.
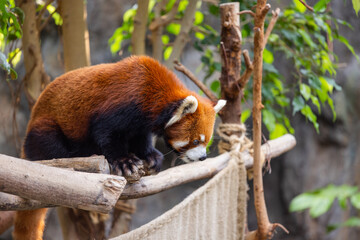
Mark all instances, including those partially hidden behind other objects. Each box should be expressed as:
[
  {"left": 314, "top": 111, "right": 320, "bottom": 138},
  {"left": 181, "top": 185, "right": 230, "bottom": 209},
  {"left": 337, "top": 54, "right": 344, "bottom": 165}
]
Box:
[{"left": 13, "top": 208, "right": 47, "bottom": 240}]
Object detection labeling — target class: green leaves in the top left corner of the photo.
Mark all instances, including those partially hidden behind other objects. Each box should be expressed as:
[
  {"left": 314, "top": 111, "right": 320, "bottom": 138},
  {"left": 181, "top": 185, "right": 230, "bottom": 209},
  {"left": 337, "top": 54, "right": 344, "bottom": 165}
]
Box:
[{"left": 0, "top": 0, "right": 24, "bottom": 79}]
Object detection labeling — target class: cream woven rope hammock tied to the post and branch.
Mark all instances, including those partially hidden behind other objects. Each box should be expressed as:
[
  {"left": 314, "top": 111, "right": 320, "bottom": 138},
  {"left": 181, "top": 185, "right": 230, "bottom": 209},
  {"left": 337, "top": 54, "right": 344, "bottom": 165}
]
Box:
[{"left": 113, "top": 124, "right": 251, "bottom": 240}]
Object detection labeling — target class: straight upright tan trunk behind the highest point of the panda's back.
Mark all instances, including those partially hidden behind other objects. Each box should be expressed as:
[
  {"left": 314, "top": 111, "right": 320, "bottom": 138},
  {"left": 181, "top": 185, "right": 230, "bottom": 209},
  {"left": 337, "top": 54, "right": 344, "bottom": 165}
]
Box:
[{"left": 131, "top": 0, "right": 149, "bottom": 55}]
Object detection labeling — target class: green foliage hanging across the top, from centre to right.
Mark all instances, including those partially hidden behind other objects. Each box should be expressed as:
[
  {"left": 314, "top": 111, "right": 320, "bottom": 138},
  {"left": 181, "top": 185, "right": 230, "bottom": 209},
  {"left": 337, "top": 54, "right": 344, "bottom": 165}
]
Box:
[{"left": 109, "top": 0, "right": 358, "bottom": 138}]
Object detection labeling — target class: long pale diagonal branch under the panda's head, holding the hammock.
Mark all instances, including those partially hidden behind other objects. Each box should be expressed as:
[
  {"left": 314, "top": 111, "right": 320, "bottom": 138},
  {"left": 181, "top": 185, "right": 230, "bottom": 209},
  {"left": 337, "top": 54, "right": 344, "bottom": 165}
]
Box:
[{"left": 0, "top": 134, "right": 296, "bottom": 210}]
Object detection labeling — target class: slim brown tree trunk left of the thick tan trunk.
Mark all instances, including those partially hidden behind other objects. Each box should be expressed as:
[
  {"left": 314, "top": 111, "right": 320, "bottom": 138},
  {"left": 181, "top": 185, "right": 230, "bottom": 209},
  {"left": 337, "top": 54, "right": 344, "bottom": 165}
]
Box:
[{"left": 17, "top": 0, "right": 50, "bottom": 108}]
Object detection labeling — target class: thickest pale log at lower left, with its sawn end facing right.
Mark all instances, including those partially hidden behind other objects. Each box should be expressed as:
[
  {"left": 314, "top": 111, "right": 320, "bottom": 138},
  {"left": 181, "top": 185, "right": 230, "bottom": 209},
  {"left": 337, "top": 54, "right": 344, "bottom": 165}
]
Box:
[{"left": 0, "top": 155, "right": 126, "bottom": 213}]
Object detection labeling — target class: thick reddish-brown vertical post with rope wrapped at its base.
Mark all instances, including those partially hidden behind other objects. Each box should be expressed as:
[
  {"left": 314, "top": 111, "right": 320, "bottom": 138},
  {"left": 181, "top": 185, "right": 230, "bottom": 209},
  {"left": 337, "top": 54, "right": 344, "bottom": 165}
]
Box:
[{"left": 219, "top": 3, "right": 242, "bottom": 123}]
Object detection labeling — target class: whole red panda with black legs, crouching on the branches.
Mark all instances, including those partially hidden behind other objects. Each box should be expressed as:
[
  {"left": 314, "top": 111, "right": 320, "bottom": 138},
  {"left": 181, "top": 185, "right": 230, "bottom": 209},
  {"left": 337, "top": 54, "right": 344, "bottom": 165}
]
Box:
[{"left": 13, "top": 56, "right": 225, "bottom": 239}]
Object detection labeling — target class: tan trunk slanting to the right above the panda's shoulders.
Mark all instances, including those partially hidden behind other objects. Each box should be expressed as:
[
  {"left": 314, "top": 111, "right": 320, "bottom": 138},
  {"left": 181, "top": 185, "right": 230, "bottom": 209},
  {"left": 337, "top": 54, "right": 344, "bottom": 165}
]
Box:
[{"left": 165, "top": 0, "right": 200, "bottom": 69}]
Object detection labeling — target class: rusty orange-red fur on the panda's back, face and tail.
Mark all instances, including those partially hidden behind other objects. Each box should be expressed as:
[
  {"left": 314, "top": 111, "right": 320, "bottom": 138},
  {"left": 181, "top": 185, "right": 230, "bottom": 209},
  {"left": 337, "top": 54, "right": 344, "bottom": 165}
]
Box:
[{"left": 14, "top": 57, "right": 215, "bottom": 240}]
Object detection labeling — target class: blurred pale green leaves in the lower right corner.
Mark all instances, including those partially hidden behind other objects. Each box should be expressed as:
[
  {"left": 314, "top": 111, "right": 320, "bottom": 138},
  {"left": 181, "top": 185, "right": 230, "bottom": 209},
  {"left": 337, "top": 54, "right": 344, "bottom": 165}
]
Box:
[{"left": 290, "top": 184, "right": 360, "bottom": 231}]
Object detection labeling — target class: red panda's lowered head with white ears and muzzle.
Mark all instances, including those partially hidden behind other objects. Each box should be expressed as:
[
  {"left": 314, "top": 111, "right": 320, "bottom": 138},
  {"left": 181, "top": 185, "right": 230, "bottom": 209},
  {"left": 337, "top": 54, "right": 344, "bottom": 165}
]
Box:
[{"left": 165, "top": 95, "right": 226, "bottom": 161}]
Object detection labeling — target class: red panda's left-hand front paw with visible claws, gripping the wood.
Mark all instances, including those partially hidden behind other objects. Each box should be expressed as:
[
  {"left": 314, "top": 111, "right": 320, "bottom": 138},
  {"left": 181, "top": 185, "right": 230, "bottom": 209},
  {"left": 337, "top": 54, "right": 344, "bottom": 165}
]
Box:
[{"left": 113, "top": 154, "right": 145, "bottom": 183}]
